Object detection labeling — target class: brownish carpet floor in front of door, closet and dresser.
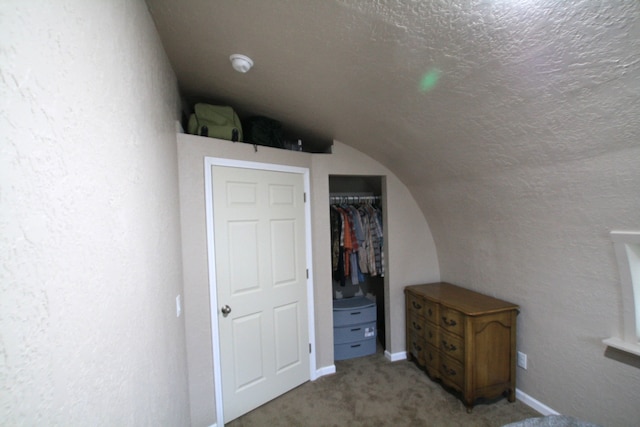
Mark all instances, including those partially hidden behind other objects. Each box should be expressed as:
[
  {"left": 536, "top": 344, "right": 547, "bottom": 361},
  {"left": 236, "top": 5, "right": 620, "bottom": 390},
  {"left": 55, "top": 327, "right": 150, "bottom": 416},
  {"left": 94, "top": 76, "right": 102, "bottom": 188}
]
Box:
[{"left": 226, "top": 351, "right": 540, "bottom": 427}]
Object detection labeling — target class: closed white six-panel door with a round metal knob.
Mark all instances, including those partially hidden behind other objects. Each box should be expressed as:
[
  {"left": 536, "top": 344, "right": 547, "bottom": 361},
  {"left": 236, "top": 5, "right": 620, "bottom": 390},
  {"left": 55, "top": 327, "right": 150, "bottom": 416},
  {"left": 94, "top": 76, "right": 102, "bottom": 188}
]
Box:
[{"left": 211, "top": 166, "right": 309, "bottom": 422}]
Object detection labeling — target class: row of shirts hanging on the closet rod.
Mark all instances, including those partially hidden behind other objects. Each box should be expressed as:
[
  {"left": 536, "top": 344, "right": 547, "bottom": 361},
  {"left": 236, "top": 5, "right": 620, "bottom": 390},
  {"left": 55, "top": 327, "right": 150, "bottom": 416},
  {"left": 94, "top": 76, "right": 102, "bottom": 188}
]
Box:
[{"left": 330, "top": 195, "right": 384, "bottom": 286}]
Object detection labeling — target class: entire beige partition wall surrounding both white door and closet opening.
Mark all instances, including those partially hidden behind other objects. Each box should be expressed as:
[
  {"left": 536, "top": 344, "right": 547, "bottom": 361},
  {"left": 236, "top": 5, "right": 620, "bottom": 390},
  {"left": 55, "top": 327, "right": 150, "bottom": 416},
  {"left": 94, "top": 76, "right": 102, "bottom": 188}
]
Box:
[{"left": 178, "top": 134, "right": 439, "bottom": 426}]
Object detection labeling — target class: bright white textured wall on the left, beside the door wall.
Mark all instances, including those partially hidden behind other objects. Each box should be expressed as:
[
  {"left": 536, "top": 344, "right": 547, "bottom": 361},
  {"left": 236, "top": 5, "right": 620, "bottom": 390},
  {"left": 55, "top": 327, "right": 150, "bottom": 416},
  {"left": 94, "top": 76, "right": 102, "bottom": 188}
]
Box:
[{"left": 0, "top": 0, "right": 189, "bottom": 426}]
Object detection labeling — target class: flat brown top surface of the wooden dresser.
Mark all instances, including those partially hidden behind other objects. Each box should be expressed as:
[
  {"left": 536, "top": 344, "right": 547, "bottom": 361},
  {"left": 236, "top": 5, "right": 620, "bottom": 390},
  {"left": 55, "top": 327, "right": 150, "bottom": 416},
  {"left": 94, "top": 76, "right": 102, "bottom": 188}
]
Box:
[{"left": 405, "top": 282, "right": 518, "bottom": 315}]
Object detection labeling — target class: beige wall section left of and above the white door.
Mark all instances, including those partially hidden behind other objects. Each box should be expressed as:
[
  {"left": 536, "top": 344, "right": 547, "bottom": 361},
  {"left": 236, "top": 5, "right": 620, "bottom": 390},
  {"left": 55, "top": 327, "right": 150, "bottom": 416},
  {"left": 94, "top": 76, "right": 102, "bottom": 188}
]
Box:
[{"left": 177, "top": 134, "right": 310, "bottom": 427}]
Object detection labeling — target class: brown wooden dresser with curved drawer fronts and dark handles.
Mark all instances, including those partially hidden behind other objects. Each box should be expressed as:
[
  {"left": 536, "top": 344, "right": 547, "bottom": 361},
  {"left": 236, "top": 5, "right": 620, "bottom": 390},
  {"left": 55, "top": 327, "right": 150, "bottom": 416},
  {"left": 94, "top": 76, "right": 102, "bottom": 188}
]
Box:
[{"left": 405, "top": 283, "right": 518, "bottom": 412}]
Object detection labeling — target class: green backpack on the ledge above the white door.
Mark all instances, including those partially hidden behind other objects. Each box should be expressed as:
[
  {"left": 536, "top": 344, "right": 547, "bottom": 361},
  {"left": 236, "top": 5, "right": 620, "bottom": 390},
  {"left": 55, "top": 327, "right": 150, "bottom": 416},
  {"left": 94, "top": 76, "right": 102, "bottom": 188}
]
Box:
[{"left": 187, "top": 103, "right": 243, "bottom": 141}]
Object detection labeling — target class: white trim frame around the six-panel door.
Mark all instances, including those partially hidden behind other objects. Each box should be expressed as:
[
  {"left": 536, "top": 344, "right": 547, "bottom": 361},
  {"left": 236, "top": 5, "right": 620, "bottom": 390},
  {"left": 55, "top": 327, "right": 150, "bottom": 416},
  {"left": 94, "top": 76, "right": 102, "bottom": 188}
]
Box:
[{"left": 204, "top": 157, "right": 316, "bottom": 426}]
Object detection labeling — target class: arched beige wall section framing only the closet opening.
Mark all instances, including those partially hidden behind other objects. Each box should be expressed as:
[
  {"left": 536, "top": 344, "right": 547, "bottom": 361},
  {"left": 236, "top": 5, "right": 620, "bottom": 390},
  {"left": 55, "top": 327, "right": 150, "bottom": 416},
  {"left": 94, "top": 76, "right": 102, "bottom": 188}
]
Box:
[{"left": 311, "top": 142, "right": 440, "bottom": 367}]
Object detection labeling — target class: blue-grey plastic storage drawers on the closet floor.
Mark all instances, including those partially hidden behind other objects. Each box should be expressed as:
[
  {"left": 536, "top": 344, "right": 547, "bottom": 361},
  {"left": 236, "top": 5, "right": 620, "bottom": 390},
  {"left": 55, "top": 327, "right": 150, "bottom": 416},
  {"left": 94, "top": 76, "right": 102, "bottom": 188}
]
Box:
[{"left": 333, "top": 297, "right": 376, "bottom": 360}]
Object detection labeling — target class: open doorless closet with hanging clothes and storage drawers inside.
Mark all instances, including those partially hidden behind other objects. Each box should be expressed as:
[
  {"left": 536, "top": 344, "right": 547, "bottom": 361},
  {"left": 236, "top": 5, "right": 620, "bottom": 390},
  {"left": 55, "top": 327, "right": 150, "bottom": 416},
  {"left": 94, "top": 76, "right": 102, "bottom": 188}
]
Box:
[{"left": 327, "top": 175, "right": 386, "bottom": 360}]
